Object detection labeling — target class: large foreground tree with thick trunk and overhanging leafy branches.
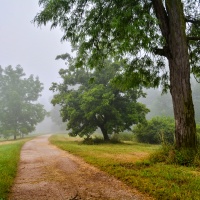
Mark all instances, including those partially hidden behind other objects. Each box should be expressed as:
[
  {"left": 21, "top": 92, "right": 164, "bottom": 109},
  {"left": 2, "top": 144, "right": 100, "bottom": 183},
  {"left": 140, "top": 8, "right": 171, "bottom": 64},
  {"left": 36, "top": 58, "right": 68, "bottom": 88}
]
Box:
[{"left": 34, "top": 0, "right": 200, "bottom": 149}]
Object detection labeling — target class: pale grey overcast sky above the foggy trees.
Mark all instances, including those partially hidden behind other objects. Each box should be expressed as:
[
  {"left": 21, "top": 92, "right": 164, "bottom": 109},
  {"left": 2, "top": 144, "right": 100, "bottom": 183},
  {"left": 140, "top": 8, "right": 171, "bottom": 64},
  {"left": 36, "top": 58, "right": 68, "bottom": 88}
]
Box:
[{"left": 0, "top": 0, "right": 70, "bottom": 109}]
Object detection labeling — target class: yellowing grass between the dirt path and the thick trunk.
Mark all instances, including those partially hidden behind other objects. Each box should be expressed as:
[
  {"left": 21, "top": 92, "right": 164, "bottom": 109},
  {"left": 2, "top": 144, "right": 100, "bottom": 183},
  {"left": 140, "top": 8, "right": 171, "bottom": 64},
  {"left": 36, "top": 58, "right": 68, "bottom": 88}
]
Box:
[{"left": 50, "top": 135, "right": 200, "bottom": 200}]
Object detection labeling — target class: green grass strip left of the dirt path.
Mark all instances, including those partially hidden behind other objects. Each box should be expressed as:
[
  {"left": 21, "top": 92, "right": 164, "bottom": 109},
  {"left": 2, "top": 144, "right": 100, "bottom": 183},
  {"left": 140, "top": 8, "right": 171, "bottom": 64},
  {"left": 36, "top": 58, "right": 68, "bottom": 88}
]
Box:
[{"left": 0, "top": 138, "right": 30, "bottom": 200}]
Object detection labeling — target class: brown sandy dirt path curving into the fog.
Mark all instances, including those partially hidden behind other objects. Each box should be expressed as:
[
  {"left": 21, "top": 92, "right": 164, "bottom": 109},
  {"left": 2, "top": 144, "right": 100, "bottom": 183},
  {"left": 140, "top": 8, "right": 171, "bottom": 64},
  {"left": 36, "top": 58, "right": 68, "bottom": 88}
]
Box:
[{"left": 9, "top": 135, "right": 153, "bottom": 200}]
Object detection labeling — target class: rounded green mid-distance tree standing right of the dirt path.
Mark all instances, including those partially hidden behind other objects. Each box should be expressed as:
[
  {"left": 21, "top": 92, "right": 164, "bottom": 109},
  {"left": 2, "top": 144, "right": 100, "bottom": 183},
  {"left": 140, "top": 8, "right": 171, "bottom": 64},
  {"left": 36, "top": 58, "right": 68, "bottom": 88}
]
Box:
[{"left": 51, "top": 57, "right": 148, "bottom": 140}]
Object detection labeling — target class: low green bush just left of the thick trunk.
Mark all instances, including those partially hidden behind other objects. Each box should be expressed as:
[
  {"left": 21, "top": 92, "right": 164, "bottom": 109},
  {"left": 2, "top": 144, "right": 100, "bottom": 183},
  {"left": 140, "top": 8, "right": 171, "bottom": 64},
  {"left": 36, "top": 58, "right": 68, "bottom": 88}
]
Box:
[{"left": 133, "top": 117, "right": 174, "bottom": 144}]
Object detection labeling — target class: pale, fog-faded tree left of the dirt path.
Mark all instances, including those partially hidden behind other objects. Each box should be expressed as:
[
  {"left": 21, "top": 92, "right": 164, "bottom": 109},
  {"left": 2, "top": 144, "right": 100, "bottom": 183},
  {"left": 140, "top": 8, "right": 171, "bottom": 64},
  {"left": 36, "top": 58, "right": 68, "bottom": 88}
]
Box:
[{"left": 0, "top": 66, "right": 46, "bottom": 139}]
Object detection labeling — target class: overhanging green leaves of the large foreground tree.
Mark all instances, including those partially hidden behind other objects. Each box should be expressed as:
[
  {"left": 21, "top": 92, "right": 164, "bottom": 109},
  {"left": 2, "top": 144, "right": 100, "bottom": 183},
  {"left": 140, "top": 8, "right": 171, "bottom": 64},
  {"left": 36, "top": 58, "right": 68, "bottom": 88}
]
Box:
[{"left": 34, "top": 0, "right": 200, "bottom": 89}]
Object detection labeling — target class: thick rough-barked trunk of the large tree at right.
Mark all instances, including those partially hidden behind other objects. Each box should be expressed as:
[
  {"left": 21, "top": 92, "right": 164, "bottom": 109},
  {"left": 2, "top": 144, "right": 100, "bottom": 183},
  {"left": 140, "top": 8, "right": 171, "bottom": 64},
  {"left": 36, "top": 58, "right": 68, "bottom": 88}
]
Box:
[{"left": 153, "top": 0, "right": 197, "bottom": 149}]
